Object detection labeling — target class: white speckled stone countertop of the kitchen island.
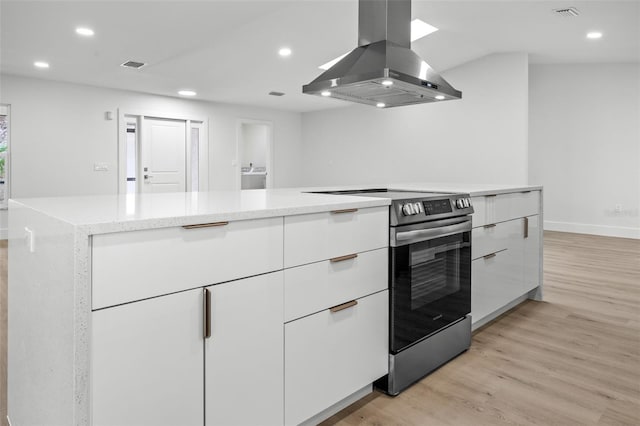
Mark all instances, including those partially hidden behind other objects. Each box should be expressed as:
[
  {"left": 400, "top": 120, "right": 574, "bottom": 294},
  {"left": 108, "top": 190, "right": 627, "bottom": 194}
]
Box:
[{"left": 10, "top": 182, "right": 542, "bottom": 235}]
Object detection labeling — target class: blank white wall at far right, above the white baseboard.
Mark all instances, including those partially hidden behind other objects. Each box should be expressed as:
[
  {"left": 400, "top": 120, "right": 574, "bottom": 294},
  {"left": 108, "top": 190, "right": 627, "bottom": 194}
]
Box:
[{"left": 529, "top": 64, "right": 640, "bottom": 238}]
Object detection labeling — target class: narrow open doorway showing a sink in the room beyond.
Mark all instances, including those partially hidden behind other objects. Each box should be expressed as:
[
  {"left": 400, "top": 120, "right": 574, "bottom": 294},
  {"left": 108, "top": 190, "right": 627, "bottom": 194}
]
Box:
[{"left": 237, "top": 119, "right": 273, "bottom": 189}]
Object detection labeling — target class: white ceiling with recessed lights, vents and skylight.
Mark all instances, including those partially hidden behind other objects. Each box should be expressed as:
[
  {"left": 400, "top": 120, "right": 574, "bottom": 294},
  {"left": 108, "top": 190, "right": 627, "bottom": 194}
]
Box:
[{"left": 0, "top": 0, "right": 640, "bottom": 112}]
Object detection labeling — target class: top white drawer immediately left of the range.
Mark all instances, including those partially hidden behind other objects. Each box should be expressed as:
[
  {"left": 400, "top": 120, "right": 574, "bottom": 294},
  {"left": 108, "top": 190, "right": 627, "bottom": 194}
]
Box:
[{"left": 284, "top": 206, "right": 389, "bottom": 268}]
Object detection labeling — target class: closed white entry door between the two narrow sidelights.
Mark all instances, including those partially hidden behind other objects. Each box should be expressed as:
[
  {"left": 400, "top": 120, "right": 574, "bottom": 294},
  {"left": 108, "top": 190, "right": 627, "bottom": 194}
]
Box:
[{"left": 140, "top": 117, "right": 187, "bottom": 192}]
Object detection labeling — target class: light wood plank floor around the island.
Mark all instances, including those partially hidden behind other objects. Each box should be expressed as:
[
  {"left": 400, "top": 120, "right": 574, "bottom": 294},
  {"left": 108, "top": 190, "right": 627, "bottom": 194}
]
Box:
[{"left": 0, "top": 232, "right": 640, "bottom": 426}]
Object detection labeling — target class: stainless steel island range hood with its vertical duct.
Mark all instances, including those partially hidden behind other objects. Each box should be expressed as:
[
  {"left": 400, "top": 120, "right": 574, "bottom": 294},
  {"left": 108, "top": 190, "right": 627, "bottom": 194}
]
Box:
[{"left": 302, "top": 0, "right": 462, "bottom": 108}]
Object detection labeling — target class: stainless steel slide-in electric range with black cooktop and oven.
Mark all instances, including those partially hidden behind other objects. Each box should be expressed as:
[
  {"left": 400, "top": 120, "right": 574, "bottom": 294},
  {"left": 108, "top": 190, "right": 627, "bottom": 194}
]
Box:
[{"left": 316, "top": 189, "right": 473, "bottom": 395}]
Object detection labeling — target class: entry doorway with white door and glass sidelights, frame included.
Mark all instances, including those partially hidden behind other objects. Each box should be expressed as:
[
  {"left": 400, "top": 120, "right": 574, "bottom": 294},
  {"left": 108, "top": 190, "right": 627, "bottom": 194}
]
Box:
[{"left": 118, "top": 114, "right": 209, "bottom": 194}]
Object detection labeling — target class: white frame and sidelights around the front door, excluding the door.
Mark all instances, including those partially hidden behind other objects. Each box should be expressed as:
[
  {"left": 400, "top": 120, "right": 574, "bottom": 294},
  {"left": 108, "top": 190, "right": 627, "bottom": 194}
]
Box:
[{"left": 118, "top": 108, "right": 209, "bottom": 194}]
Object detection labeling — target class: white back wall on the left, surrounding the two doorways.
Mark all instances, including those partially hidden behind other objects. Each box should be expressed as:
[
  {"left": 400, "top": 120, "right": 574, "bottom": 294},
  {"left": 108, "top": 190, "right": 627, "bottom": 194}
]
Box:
[{"left": 0, "top": 75, "right": 301, "bottom": 198}]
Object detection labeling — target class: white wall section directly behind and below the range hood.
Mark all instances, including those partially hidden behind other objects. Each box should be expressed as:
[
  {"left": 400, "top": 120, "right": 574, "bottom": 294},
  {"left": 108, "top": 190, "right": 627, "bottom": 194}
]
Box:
[{"left": 302, "top": 53, "right": 528, "bottom": 185}]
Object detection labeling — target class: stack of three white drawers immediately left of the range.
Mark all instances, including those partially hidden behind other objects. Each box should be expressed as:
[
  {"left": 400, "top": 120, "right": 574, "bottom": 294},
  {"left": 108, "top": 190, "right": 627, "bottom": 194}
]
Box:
[{"left": 284, "top": 207, "right": 389, "bottom": 425}]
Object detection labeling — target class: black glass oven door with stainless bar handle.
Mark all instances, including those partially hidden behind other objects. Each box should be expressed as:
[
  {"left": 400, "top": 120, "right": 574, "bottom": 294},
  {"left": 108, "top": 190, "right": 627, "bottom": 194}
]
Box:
[{"left": 389, "top": 216, "right": 471, "bottom": 354}]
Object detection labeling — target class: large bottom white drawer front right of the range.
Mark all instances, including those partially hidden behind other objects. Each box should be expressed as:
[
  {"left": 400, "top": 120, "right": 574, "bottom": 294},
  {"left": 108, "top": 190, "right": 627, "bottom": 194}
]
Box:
[{"left": 471, "top": 249, "right": 525, "bottom": 323}]
